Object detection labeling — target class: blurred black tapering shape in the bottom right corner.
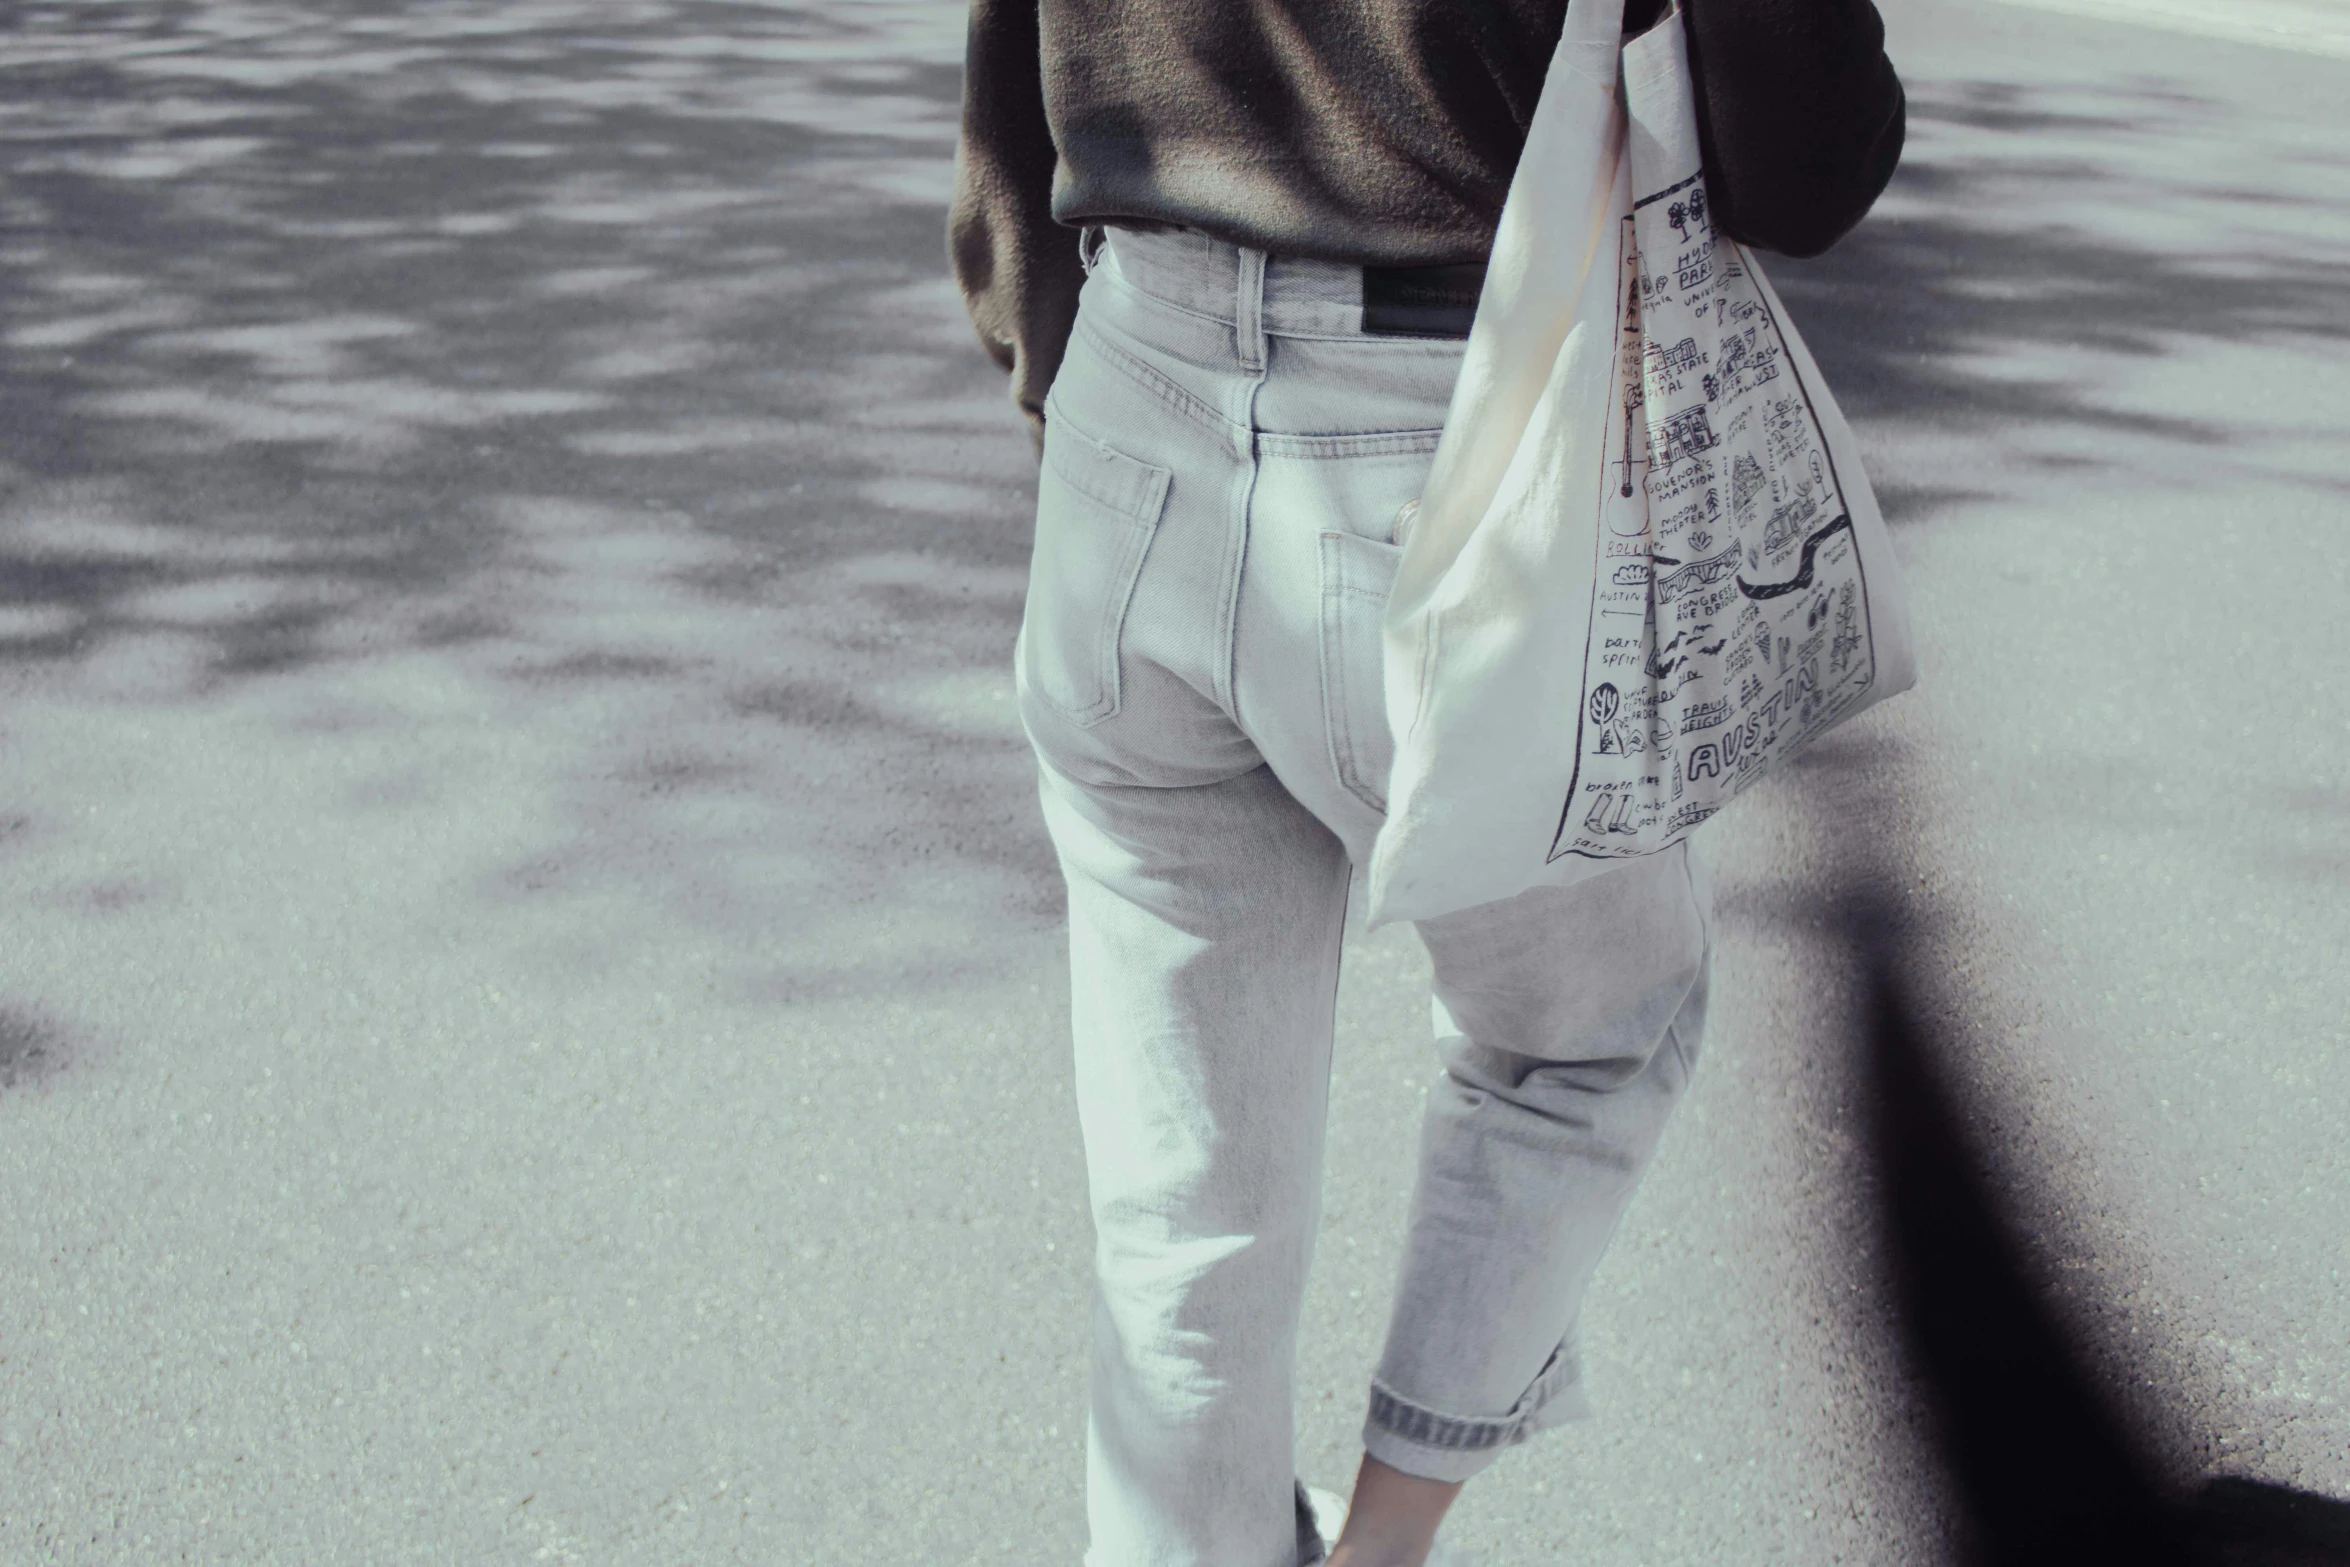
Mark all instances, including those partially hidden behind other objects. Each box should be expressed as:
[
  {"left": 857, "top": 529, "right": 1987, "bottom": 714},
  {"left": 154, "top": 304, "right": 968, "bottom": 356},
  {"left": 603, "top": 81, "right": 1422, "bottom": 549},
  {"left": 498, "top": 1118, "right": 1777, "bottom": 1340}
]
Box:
[{"left": 1852, "top": 912, "right": 2350, "bottom": 1567}]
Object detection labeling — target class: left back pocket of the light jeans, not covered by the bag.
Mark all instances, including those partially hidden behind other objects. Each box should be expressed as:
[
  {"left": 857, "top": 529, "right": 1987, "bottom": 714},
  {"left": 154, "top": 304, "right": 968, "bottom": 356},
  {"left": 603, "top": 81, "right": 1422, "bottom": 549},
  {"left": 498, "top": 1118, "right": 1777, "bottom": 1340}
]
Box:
[{"left": 1020, "top": 409, "right": 1168, "bottom": 726}]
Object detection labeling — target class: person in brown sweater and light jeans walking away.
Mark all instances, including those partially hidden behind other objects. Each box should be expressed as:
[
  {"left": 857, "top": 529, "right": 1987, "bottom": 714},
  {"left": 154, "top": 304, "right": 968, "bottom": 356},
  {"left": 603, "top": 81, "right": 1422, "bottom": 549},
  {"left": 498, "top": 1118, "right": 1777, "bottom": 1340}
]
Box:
[{"left": 949, "top": 0, "right": 1904, "bottom": 1567}]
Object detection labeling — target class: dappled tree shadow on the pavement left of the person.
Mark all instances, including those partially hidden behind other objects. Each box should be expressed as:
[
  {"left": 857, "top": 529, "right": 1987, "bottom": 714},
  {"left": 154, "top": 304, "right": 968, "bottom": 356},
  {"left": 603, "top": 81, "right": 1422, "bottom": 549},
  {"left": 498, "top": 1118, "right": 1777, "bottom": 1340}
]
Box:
[{"left": 0, "top": 0, "right": 1058, "bottom": 994}]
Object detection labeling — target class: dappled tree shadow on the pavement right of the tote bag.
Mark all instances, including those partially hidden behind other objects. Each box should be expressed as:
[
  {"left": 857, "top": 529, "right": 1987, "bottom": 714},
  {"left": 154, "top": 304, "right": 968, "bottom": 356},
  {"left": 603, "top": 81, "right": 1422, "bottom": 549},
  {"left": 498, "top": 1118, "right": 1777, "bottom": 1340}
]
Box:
[{"left": 1765, "top": 68, "right": 2350, "bottom": 524}]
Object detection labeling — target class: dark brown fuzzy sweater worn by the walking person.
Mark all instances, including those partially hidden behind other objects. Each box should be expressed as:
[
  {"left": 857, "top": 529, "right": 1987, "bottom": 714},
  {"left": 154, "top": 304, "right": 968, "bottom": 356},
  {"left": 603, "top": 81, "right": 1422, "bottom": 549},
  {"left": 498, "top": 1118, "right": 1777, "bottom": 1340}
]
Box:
[{"left": 949, "top": 0, "right": 1904, "bottom": 421}]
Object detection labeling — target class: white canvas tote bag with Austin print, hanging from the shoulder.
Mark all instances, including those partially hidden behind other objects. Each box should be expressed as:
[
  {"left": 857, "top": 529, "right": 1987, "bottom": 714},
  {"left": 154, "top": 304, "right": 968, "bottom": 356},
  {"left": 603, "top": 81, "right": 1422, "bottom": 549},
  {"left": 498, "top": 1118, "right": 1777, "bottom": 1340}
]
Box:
[{"left": 1370, "top": 0, "right": 1915, "bottom": 923}]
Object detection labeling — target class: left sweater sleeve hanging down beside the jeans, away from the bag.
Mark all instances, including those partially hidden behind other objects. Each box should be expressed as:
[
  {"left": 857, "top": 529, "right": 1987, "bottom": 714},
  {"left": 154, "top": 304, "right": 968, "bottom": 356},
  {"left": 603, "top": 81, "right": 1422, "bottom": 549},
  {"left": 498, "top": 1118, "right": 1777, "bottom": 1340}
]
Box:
[{"left": 947, "top": 0, "right": 1086, "bottom": 439}]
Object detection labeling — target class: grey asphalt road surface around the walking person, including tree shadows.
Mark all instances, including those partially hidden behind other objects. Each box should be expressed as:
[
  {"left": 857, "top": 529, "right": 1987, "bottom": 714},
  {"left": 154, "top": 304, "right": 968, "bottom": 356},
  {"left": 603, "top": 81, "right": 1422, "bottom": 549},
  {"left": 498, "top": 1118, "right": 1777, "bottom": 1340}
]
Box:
[{"left": 0, "top": 0, "right": 2350, "bottom": 1567}]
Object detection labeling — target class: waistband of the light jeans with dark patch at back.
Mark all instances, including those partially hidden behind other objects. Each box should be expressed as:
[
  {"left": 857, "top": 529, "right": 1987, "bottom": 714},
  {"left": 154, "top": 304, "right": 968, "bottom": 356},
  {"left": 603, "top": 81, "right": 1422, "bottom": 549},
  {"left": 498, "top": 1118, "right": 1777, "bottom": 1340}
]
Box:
[{"left": 1086, "top": 228, "right": 1485, "bottom": 338}]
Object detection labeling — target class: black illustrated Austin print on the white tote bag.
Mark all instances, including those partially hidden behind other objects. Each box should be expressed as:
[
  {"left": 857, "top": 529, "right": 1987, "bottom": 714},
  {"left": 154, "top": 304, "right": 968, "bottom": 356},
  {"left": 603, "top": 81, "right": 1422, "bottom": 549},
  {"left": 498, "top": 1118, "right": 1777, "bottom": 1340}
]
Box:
[{"left": 1549, "top": 164, "right": 1885, "bottom": 845}]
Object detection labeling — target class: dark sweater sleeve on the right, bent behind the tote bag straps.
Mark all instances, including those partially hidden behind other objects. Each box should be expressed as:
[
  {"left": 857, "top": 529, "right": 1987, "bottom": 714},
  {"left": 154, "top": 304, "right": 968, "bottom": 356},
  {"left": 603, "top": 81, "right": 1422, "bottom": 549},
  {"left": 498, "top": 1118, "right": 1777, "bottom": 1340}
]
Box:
[{"left": 1683, "top": 0, "right": 1906, "bottom": 256}]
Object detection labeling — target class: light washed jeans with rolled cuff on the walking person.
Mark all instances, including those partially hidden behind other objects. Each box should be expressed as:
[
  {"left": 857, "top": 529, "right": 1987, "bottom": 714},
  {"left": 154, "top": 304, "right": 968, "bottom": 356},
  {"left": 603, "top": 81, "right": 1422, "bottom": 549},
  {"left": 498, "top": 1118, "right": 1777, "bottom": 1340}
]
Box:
[{"left": 1015, "top": 233, "right": 1713, "bottom": 1567}]
